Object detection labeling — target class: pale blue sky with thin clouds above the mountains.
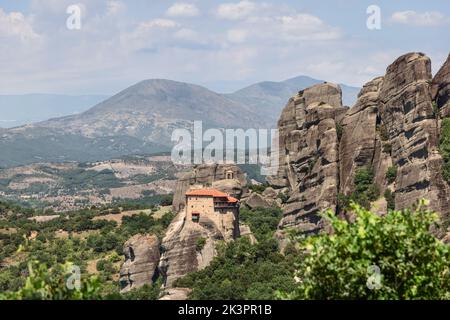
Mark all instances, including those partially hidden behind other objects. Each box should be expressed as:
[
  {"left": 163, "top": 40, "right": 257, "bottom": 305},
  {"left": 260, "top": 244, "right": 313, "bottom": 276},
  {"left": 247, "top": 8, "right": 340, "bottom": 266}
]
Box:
[{"left": 0, "top": 0, "right": 450, "bottom": 95}]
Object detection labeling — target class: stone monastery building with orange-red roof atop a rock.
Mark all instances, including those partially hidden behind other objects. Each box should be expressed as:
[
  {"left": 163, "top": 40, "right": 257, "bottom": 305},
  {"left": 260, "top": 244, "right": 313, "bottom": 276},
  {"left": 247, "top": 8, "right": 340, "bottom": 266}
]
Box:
[{"left": 186, "top": 189, "right": 239, "bottom": 240}]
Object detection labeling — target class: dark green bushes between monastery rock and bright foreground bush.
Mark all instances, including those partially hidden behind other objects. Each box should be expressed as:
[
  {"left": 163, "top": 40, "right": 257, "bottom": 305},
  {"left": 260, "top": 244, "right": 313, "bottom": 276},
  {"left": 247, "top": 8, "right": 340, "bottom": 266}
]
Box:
[{"left": 175, "top": 237, "right": 297, "bottom": 300}]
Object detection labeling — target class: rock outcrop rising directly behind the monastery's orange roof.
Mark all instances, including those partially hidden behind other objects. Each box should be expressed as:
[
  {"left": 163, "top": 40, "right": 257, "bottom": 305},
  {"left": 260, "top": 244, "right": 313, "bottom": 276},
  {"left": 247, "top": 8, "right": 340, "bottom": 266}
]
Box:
[{"left": 173, "top": 164, "right": 247, "bottom": 212}]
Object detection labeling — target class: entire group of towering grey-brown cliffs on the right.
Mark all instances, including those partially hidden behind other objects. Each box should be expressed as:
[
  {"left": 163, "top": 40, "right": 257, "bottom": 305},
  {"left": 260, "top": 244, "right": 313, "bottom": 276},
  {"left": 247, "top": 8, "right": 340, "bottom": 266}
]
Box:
[{"left": 268, "top": 53, "right": 450, "bottom": 233}]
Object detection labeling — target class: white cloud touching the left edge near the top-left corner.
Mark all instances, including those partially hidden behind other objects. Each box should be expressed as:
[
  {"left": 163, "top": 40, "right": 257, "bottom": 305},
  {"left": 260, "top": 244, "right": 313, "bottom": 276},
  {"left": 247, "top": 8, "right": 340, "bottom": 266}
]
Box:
[{"left": 0, "top": 8, "right": 40, "bottom": 41}]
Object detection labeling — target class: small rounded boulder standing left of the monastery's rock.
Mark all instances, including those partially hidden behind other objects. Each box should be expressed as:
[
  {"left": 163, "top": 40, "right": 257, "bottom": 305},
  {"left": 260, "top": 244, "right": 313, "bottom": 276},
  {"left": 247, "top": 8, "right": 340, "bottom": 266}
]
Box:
[{"left": 119, "top": 234, "right": 160, "bottom": 293}]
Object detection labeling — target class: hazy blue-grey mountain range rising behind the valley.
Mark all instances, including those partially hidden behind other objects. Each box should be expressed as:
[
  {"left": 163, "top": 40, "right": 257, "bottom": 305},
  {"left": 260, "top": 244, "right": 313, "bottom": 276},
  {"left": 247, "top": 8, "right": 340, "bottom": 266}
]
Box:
[{"left": 0, "top": 76, "right": 359, "bottom": 167}]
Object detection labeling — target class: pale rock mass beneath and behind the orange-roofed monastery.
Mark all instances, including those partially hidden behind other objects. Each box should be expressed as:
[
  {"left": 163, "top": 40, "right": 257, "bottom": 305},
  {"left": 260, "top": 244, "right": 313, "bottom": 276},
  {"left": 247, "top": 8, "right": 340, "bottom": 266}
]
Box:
[{"left": 159, "top": 164, "right": 246, "bottom": 287}]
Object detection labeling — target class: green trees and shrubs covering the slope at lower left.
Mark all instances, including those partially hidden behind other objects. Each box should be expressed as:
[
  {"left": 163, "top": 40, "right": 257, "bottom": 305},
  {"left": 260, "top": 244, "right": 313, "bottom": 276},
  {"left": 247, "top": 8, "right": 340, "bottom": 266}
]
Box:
[{"left": 0, "top": 201, "right": 174, "bottom": 300}]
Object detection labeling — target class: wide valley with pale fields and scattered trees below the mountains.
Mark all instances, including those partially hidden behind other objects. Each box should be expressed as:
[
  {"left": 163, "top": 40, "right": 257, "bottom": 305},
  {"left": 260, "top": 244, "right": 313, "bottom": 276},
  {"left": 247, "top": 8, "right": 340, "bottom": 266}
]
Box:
[{"left": 0, "top": 155, "right": 181, "bottom": 212}]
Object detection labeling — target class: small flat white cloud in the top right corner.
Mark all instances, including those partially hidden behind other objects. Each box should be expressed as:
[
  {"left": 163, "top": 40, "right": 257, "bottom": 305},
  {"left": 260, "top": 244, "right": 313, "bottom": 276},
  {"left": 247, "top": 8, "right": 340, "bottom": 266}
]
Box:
[{"left": 391, "top": 10, "right": 450, "bottom": 27}]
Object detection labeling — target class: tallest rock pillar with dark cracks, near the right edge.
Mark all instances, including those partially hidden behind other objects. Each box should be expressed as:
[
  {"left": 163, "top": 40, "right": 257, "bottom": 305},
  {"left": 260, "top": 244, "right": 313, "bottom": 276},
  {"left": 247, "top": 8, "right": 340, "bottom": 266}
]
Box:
[{"left": 380, "top": 53, "right": 449, "bottom": 220}]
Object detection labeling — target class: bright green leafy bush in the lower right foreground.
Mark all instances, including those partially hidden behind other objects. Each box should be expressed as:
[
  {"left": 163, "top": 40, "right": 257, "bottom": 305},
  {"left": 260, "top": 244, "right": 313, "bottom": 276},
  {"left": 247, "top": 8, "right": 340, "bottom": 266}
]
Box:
[{"left": 280, "top": 201, "right": 450, "bottom": 299}]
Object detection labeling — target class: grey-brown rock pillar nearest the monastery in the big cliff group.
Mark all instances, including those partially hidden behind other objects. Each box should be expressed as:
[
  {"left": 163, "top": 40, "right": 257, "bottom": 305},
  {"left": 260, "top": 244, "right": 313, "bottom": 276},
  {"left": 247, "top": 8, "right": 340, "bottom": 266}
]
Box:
[{"left": 269, "top": 83, "right": 346, "bottom": 232}]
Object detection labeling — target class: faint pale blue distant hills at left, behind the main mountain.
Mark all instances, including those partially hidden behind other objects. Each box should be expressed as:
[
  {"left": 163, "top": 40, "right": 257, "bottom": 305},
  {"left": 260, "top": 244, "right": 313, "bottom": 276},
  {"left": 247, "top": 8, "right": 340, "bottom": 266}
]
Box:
[{"left": 0, "top": 94, "right": 108, "bottom": 128}]
